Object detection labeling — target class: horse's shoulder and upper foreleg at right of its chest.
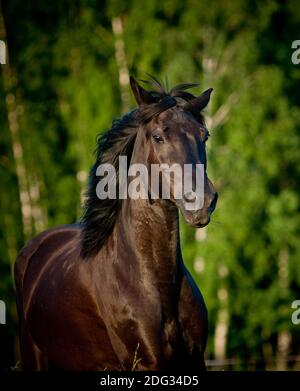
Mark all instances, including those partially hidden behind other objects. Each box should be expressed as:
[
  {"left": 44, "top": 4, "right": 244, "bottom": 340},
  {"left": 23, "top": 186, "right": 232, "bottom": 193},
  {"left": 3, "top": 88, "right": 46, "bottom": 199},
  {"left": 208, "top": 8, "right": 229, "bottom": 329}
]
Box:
[{"left": 178, "top": 271, "right": 208, "bottom": 371}]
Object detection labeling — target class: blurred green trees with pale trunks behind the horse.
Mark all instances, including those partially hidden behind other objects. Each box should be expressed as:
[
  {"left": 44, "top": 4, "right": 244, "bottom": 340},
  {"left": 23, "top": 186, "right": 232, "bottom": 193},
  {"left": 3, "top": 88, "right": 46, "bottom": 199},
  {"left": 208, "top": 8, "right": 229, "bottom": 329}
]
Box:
[{"left": 0, "top": 0, "right": 300, "bottom": 370}]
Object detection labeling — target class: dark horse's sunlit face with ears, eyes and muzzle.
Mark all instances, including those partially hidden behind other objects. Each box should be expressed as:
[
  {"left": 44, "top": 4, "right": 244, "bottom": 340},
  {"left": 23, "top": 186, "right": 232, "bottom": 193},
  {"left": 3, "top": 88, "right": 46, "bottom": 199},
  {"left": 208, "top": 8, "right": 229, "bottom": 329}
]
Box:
[{"left": 133, "top": 77, "right": 218, "bottom": 227}]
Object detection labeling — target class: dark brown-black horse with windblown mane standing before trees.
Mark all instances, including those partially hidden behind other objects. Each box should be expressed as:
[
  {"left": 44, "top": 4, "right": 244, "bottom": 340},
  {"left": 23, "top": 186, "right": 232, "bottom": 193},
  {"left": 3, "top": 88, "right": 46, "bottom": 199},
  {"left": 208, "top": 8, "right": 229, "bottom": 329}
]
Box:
[{"left": 15, "top": 78, "right": 217, "bottom": 370}]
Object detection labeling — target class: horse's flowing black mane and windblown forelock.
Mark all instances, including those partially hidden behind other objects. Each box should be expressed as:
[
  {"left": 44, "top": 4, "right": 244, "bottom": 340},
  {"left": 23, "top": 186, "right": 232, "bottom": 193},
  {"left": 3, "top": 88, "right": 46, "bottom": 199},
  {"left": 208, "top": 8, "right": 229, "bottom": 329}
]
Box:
[{"left": 81, "top": 77, "right": 204, "bottom": 258}]
